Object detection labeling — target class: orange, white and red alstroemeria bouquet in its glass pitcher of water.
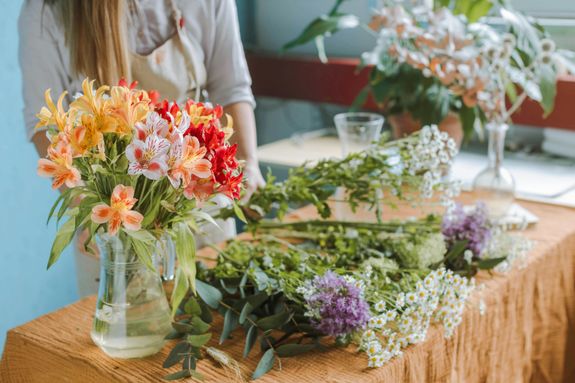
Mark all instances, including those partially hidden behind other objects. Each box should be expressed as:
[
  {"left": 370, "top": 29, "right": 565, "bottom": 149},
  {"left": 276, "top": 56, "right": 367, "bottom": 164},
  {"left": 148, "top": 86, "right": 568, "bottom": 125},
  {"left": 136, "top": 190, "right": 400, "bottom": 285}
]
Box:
[{"left": 37, "top": 79, "right": 242, "bottom": 357}]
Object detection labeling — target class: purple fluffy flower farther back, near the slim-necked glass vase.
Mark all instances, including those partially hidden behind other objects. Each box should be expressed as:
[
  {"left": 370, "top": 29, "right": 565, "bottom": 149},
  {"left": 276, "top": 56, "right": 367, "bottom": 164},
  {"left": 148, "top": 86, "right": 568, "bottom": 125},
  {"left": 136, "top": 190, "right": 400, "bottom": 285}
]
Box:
[{"left": 442, "top": 203, "right": 491, "bottom": 258}]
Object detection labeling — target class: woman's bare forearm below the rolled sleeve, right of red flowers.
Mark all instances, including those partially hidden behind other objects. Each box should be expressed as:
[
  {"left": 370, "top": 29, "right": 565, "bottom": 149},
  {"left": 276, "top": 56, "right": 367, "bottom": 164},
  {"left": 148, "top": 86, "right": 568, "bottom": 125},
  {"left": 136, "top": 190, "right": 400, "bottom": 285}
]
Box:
[{"left": 224, "top": 102, "right": 265, "bottom": 198}]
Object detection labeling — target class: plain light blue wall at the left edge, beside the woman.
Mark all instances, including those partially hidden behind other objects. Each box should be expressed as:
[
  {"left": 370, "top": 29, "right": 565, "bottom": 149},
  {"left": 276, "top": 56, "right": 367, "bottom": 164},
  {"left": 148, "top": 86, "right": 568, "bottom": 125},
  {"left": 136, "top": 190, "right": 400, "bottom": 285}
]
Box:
[{"left": 0, "top": 0, "right": 78, "bottom": 351}]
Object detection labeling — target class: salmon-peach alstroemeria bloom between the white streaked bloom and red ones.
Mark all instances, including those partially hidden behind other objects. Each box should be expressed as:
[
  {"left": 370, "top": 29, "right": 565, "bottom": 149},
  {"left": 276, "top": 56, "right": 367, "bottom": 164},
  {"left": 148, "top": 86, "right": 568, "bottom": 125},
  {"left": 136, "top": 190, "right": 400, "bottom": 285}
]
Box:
[{"left": 168, "top": 136, "right": 212, "bottom": 188}]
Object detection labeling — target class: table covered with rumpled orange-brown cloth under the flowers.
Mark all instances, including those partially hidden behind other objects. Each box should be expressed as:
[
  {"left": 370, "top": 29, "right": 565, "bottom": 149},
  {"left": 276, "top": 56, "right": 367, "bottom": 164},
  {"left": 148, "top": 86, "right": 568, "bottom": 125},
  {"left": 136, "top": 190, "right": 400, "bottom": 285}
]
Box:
[{"left": 0, "top": 196, "right": 575, "bottom": 383}]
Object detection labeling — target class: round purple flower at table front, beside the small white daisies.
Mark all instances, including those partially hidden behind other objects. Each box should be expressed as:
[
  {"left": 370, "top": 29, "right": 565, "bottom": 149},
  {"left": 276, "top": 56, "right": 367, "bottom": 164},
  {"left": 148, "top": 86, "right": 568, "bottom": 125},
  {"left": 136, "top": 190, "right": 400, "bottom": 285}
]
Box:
[{"left": 306, "top": 271, "right": 370, "bottom": 336}]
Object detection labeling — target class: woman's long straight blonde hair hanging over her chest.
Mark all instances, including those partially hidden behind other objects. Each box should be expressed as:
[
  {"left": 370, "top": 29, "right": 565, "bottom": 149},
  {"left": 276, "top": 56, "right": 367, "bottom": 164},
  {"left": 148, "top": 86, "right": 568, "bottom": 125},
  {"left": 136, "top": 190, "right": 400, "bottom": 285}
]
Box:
[{"left": 47, "top": 0, "right": 132, "bottom": 85}]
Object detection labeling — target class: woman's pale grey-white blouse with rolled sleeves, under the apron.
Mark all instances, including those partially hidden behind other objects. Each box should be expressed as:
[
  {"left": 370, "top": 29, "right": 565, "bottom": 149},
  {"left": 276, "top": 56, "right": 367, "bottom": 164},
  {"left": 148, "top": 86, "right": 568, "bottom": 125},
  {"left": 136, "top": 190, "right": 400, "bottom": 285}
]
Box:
[{"left": 18, "top": 0, "right": 255, "bottom": 138}]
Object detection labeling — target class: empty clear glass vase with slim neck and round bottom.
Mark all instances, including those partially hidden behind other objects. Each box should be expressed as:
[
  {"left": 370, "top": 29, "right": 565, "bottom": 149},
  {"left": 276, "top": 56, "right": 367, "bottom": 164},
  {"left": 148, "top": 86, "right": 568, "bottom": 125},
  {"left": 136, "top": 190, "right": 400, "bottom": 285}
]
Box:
[{"left": 473, "top": 123, "right": 515, "bottom": 219}]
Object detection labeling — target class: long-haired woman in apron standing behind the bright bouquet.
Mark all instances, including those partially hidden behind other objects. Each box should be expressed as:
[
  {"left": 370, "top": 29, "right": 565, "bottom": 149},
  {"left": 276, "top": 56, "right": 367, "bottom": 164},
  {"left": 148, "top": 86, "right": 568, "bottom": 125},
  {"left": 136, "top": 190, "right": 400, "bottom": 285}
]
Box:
[{"left": 19, "top": 0, "right": 264, "bottom": 294}]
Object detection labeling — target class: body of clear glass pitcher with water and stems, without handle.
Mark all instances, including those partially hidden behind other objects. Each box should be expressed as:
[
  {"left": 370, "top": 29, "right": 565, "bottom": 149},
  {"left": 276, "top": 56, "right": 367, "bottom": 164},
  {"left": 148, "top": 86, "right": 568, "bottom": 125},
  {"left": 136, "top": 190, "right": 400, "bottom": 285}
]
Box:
[{"left": 91, "top": 234, "right": 171, "bottom": 358}]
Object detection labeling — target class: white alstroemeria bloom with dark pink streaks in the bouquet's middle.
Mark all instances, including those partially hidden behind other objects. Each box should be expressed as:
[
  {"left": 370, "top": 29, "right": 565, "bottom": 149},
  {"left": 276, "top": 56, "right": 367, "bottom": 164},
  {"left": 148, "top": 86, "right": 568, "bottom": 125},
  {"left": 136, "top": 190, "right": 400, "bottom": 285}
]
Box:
[{"left": 126, "top": 134, "right": 170, "bottom": 180}]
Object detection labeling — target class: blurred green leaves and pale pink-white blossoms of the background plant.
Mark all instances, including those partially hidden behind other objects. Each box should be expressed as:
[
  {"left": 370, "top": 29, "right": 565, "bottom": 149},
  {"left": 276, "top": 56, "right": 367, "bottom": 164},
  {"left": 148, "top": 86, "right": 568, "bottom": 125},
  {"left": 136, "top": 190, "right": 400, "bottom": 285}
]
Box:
[{"left": 284, "top": 0, "right": 575, "bottom": 137}]
